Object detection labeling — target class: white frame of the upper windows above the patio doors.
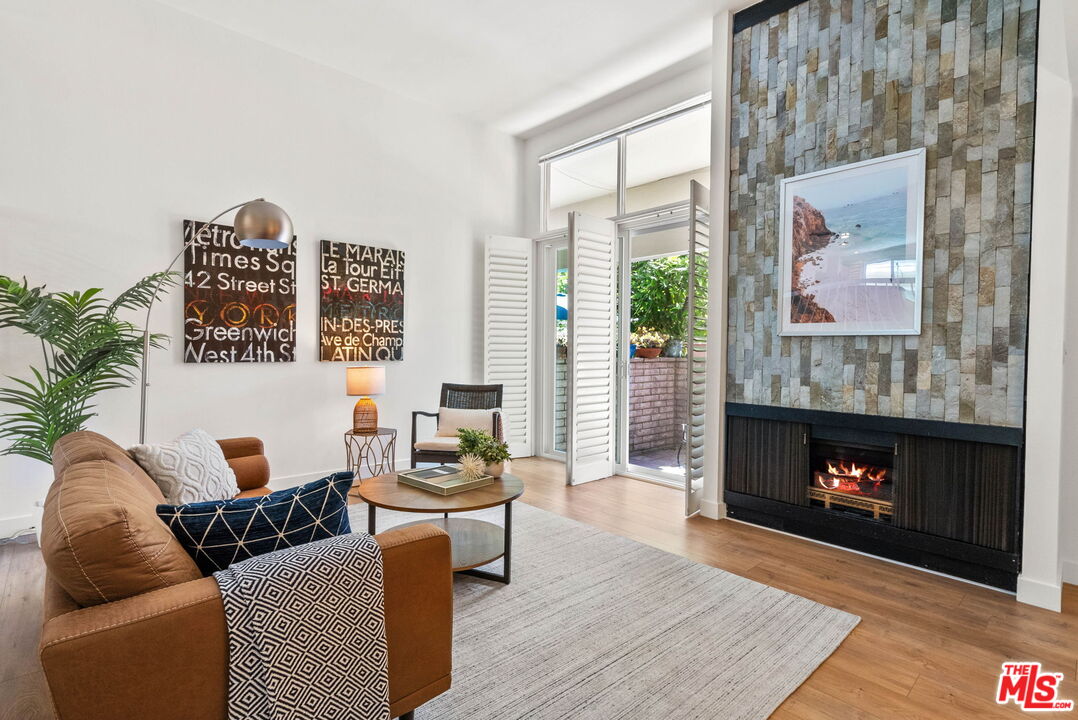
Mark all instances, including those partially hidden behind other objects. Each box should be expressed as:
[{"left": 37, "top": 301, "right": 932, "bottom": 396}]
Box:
[{"left": 539, "top": 93, "right": 711, "bottom": 235}]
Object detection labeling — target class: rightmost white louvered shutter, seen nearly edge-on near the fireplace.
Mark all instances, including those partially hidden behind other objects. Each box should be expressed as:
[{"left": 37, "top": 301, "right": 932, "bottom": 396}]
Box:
[{"left": 685, "top": 180, "right": 710, "bottom": 515}]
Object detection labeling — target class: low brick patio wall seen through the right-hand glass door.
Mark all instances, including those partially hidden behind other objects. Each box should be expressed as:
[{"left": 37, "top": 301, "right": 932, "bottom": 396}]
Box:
[{"left": 628, "top": 358, "right": 689, "bottom": 452}]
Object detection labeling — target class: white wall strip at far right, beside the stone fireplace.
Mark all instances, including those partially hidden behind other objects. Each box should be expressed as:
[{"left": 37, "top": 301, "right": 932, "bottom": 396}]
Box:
[{"left": 1018, "top": 0, "right": 1078, "bottom": 610}]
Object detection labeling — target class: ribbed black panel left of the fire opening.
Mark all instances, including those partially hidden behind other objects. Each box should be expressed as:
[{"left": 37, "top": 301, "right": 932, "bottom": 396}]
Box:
[{"left": 727, "top": 417, "right": 810, "bottom": 506}]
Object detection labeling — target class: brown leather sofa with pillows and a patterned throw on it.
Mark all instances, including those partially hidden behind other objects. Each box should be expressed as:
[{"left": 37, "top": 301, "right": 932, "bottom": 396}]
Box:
[{"left": 41, "top": 431, "right": 453, "bottom": 720}]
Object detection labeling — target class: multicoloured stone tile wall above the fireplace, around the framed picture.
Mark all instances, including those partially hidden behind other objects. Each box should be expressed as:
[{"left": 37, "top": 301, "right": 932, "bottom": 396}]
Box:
[{"left": 727, "top": 0, "right": 1039, "bottom": 427}]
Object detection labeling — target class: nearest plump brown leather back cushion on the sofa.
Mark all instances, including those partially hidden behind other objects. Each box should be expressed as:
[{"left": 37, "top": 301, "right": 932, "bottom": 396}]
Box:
[{"left": 41, "top": 452, "right": 202, "bottom": 607}]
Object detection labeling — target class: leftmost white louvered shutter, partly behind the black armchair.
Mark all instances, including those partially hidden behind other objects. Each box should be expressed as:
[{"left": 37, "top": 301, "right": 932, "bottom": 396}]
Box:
[{"left": 483, "top": 235, "right": 535, "bottom": 457}]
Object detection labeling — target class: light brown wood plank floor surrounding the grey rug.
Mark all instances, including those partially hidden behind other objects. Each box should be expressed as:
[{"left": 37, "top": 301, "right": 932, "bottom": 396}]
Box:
[{"left": 0, "top": 458, "right": 1078, "bottom": 720}]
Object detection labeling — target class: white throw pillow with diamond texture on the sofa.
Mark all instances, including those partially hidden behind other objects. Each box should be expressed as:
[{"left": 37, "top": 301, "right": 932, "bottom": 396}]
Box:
[{"left": 127, "top": 430, "right": 239, "bottom": 506}]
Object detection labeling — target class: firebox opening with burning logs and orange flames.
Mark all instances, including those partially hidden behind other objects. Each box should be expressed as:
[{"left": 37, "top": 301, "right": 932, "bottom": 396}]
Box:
[{"left": 809, "top": 438, "right": 895, "bottom": 522}]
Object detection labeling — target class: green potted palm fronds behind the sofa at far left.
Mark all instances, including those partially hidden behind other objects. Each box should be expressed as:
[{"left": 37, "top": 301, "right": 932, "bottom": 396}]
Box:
[{"left": 0, "top": 273, "right": 177, "bottom": 463}]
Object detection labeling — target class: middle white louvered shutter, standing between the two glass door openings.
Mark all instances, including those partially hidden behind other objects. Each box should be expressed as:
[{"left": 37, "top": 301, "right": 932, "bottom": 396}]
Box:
[{"left": 566, "top": 212, "right": 618, "bottom": 485}]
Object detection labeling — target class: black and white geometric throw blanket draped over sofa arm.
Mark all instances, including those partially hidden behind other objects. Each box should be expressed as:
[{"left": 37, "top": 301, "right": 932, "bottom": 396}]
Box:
[{"left": 213, "top": 532, "right": 389, "bottom": 720}]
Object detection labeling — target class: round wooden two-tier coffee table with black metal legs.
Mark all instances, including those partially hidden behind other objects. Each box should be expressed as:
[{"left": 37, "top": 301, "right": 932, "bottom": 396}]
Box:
[{"left": 356, "top": 473, "right": 524, "bottom": 584}]
